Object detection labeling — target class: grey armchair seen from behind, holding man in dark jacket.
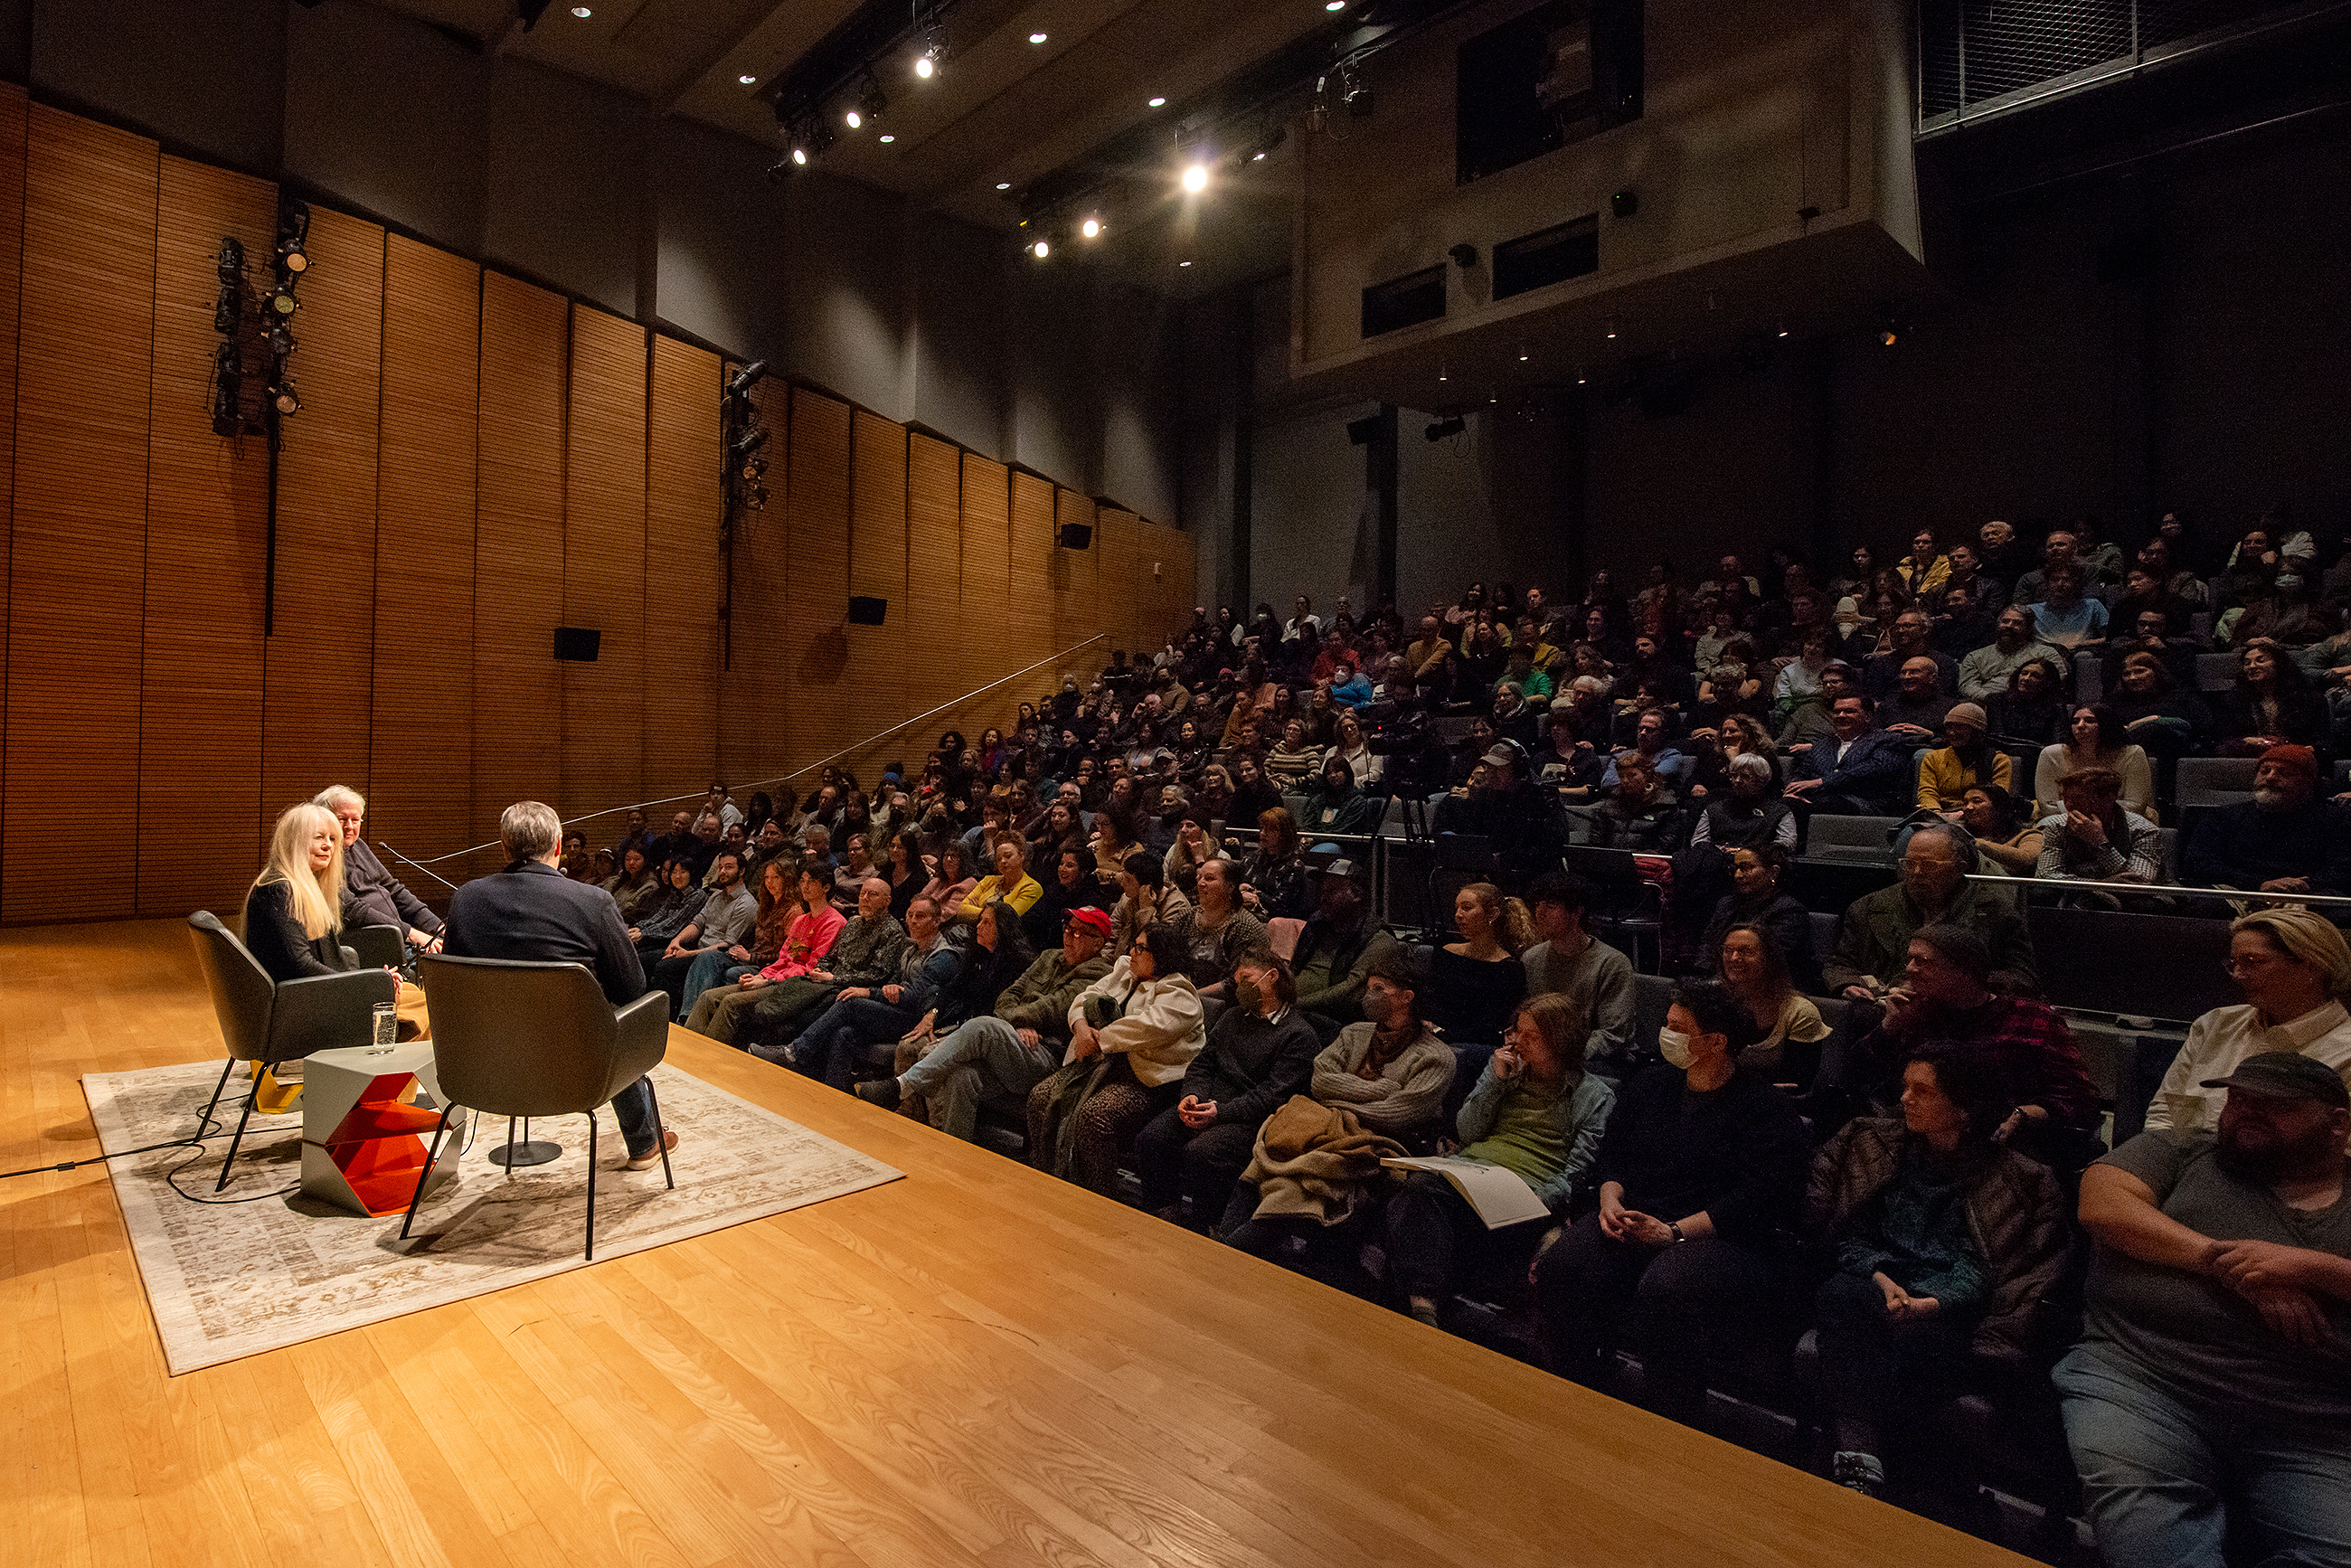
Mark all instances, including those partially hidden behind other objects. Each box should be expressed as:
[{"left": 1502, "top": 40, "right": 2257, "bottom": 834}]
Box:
[{"left": 400, "top": 954, "right": 677, "bottom": 1260}]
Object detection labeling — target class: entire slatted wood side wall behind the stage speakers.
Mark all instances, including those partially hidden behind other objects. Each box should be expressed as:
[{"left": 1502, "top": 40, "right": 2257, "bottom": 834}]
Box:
[{"left": 0, "top": 95, "right": 1192, "bottom": 924}]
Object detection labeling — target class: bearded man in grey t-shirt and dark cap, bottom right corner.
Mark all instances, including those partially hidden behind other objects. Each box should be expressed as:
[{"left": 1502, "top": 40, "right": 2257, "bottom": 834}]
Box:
[{"left": 2054, "top": 1053, "right": 2351, "bottom": 1568}]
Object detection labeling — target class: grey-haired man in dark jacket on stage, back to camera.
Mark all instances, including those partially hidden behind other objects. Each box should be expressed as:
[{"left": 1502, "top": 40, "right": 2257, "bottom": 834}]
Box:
[{"left": 442, "top": 799, "right": 677, "bottom": 1171}]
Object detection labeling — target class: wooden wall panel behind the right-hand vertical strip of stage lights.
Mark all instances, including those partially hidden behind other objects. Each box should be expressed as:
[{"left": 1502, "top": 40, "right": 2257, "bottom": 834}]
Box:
[{"left": 703, "top": 378, "right": 797, "bottom": 799}]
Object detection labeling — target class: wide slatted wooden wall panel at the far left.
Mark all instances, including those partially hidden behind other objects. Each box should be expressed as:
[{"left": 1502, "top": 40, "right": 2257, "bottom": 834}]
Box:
[{"left": 0, "top": 103, "right": 158, "bottom": 921}]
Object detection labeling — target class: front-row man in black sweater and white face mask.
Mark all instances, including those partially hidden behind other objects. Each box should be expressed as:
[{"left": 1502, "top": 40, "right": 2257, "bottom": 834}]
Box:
[{"left": 1531, "top": 983, "right": 1810, "bottom": 1424}]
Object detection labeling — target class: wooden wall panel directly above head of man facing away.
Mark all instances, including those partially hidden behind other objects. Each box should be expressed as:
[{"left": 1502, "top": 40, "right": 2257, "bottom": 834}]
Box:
[{"left": 473, "top": 273, "right": 564, "bottom": 864}]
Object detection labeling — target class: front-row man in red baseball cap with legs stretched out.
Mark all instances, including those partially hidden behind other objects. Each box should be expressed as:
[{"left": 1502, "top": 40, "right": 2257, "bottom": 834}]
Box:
[{"left": 855, "top": 907, "right": 1109, "bottom": 1142}]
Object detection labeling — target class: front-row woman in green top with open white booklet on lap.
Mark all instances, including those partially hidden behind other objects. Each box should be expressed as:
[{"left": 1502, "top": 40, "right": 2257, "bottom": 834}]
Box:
[{"left": 1387, "top": 995, "right": 1615, "bottom": 1326}]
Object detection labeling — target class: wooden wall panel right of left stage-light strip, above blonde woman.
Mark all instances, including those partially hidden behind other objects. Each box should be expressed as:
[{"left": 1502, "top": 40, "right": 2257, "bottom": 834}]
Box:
[{"left": 265, "top": 207, "right": 381, "bottom": 845}]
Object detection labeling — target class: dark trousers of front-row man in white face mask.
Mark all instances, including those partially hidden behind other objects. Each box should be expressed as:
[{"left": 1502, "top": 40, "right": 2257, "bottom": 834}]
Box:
[{"left": 1535, "top": 1213, "right": 1778, "bottom": 1424}]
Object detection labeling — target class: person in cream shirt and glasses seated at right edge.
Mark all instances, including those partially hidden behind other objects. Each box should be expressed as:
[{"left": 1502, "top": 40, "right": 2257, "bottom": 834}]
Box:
[{"left": 2147, "top": 910, "right": 2351, "bottom": 1133}]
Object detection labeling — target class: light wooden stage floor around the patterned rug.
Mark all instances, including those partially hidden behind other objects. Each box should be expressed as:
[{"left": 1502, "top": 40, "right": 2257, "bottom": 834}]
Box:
[{"left": 0, "top": 921, "right": 2022, "bottom": 1568}]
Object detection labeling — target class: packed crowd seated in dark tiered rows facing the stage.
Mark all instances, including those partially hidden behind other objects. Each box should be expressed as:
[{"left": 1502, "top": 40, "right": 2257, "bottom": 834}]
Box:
[{"left": 250, "top": 515, "right": 2351, "bottom": 1565}]
